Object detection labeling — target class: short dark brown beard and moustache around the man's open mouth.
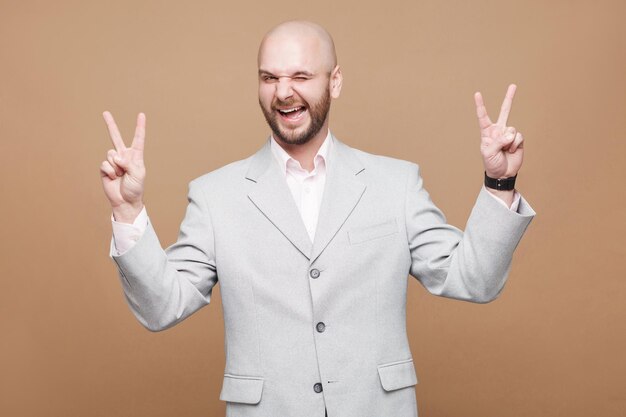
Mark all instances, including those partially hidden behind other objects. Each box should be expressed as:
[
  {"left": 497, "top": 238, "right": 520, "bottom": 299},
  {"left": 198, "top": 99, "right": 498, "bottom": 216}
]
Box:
[{"left": 259, "top": 88, "right": 331, "bottom": 145}]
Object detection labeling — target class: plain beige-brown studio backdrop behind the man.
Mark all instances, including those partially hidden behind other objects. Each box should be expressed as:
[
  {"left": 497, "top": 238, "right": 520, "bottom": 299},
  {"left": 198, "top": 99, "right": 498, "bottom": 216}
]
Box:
[{"left": 0, "top": 0, "right": 626, "bottom": 417}]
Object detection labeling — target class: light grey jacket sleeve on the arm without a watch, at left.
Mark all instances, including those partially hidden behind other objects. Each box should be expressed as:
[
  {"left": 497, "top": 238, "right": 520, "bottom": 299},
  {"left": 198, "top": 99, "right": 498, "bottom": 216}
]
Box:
[{"left": 112, "top": 181, "right": 217, "bottom": 331}]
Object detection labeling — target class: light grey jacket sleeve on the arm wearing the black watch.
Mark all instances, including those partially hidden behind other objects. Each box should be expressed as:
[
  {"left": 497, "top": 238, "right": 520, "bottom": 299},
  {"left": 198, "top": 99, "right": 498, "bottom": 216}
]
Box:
[{"left": 406, "top": 164, "right": 535, "bottom": 303}]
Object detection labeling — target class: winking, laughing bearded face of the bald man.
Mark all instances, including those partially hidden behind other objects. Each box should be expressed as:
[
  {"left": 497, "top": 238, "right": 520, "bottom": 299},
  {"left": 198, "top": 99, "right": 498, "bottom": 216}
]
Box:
[{"left": 259, "top": 33, "right": 341, "bottom": 145}]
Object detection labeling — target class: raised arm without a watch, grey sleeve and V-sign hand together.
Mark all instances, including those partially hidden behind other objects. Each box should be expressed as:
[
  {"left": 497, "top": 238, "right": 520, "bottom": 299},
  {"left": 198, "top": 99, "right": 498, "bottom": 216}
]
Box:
[{"left": 100, "top": 112, "right": 217, "bottom": 331}]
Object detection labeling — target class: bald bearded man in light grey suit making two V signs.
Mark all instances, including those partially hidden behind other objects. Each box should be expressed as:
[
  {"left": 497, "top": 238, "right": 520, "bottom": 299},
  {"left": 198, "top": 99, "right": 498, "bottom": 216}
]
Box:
[{"left": 101, "top": 21, "right": 534, "bottom": 417}]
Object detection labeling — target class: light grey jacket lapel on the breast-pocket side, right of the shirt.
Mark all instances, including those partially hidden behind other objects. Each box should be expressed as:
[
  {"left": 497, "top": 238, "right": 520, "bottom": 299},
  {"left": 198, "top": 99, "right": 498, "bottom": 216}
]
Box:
[{"left": 310, "top": 137, "right": 366, "bottom": 263}]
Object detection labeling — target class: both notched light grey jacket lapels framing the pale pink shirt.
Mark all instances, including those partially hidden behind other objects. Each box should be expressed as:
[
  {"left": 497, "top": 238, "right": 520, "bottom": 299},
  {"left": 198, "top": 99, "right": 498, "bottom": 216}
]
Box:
[{"left": 246, "top": 137, "right": 366, "bottom": 262}]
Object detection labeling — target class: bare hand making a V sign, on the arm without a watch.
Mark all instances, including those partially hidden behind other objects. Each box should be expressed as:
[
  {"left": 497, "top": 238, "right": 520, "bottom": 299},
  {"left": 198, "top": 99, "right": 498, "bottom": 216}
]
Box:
[{"left": 100, "top": 111, "right": 146, "bottom": 223}]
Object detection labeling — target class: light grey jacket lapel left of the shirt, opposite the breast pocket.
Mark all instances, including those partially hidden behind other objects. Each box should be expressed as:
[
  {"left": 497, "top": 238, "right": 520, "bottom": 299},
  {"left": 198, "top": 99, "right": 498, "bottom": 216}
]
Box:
[{"left": 246, "top": 140, "right": 312, "bottom": 259}]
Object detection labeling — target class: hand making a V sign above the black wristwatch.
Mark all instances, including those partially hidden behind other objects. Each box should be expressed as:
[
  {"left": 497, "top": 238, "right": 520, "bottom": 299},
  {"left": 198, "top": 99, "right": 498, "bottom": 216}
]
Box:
[{"left": 474, "top": 84, "right": 524, "bottom": 178}]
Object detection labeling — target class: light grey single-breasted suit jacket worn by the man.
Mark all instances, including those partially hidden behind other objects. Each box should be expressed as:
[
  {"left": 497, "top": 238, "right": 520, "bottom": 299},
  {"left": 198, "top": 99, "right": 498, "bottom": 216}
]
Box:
[{"left": 114, "top": 135, "right": 535, "bottom": 417}]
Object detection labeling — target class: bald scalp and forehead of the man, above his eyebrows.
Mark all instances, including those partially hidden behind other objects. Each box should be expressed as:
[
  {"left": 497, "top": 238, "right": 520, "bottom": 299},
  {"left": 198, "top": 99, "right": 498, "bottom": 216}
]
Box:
[{"left": 258, "top": 20, "right": 337, "bottom": 72}]
